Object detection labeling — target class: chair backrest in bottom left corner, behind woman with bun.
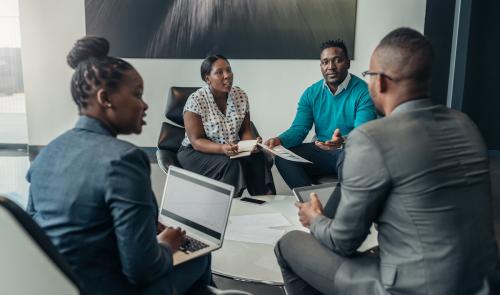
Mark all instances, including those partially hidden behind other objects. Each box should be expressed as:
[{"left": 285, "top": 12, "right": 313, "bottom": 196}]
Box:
[{"left": 0, "top": 196, "right": 82, "bottom": 294}]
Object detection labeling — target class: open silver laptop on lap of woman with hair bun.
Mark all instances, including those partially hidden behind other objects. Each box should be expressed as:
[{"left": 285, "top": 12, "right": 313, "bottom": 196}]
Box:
[{"left": 159, "top": 166, "right": 234, "bottom": 265}]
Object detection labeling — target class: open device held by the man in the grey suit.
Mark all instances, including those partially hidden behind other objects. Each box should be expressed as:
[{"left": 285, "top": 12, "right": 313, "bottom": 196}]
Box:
[{"left": 292, "top": 182, "right": 340, "bottom": 218}]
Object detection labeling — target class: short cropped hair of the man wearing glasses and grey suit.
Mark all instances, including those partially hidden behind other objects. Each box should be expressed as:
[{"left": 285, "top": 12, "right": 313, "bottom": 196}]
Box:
[{"left": 376, "top": 28, "right": 434, "bottom": 81}]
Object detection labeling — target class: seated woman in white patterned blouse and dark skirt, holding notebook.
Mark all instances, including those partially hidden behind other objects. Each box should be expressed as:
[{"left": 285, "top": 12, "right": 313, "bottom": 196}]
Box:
[{"left": 177, "top": 55, "right": 275, "bottom": 196}]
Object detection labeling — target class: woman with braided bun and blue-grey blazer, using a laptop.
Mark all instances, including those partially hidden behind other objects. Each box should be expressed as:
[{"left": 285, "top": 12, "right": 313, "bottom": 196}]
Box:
[{"left": 27, "top": 37, "right": 211, "bottom": 294}]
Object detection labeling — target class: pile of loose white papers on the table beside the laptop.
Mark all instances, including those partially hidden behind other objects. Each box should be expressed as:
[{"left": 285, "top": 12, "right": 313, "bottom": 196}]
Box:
[{"left": 225, "top": 213, "right": 291, "bottom": 245}]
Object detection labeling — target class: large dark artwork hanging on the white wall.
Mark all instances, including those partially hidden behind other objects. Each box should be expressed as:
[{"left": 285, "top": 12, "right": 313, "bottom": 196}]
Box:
[{"left": 85, "top": 0, "right": 357, "bottom": 59}]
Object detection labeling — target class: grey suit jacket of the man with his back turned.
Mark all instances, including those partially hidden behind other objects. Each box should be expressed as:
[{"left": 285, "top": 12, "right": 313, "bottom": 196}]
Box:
[{"left": 311, "top": 99, "right": 499, "bottom": 294}]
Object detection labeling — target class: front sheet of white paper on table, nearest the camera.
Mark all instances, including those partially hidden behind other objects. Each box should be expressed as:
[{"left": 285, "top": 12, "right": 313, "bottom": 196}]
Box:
[{"left": 224, "top": 224, "right": 285, "bottom": 245}]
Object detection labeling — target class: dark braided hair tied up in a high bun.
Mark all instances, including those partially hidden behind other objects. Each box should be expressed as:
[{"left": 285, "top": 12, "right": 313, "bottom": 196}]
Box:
[{"left": 66, "top": 36, "right": 133, "bottom": 111}]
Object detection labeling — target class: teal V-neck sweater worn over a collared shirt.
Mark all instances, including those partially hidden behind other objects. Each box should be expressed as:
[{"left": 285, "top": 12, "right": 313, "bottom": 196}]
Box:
[{"left": 279, "top": 74, "right": 377, "bottom": 148}]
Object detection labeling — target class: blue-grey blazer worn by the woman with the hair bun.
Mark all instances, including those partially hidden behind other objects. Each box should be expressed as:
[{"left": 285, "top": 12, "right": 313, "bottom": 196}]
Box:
[{"left": 27, "top": 116, "right": 173, "bottom": 294}]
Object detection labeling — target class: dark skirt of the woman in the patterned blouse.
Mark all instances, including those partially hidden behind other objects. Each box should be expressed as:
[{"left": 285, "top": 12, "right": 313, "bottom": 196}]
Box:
[{"left": 177, "top": 146, "right": 276, "bottom": 197}]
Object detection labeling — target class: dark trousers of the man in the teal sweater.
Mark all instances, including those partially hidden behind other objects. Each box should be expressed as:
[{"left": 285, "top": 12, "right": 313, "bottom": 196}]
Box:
[{"left": 275, "top": 143, "right": 343, "bottom": 189}]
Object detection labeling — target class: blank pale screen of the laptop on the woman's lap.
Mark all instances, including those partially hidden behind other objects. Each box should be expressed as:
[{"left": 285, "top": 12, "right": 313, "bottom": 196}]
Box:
[{"left": 161, "top": 168, "right": 232, "bottom": 239}]
